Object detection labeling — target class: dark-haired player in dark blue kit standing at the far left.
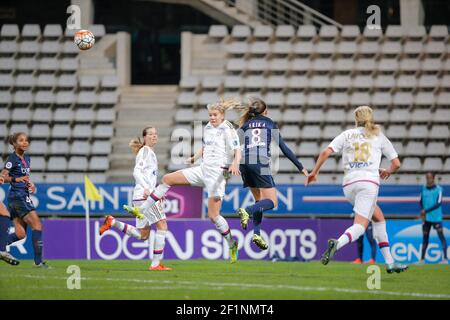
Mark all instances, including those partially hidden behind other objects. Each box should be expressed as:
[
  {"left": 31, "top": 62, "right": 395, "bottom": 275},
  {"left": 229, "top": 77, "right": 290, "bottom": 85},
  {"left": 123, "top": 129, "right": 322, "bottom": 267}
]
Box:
[{"left": 2, "top": 132, "right": 48, "bottom": 269}]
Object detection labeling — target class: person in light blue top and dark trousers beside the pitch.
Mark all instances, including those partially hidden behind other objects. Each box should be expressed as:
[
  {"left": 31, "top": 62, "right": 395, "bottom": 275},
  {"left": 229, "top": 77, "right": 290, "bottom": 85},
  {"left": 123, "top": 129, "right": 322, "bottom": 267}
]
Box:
[{"left": 419, "top": 172, "right": 448, "bottom": 264}]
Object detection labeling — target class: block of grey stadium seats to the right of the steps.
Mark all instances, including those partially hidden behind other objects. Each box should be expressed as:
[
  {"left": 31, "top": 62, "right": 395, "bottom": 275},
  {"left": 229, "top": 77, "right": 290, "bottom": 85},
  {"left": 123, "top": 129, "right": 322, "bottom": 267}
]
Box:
[{"left": 175, "top": 25, "right": 450, "bottom": 183}]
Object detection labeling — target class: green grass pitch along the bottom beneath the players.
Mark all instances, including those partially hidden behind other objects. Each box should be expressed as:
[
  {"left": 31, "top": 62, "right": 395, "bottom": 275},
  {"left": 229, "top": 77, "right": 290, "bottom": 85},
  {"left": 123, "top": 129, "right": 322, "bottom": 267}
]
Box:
[{"left": 0, "top": 260, "right": 450, "bottom": 300}]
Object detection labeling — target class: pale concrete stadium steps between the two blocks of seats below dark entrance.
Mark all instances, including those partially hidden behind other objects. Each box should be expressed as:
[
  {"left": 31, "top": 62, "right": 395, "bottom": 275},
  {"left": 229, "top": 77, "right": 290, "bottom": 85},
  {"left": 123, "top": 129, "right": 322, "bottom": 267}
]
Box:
[{"left": 107, "top": 86, "right": 178, "bottom": 182}]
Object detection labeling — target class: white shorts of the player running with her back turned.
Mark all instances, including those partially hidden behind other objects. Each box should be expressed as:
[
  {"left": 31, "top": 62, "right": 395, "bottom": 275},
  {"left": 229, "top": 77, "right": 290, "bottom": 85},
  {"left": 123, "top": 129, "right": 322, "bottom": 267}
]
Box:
[{"left": 343, "top": 181, "right": 380, "bottom": 221}]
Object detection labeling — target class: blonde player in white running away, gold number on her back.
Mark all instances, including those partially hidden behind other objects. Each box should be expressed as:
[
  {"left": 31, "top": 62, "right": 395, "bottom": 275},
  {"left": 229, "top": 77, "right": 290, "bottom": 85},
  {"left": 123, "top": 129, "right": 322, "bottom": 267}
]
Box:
[{"left": 305, "top": 106, "right": 408, "bottom": 273}]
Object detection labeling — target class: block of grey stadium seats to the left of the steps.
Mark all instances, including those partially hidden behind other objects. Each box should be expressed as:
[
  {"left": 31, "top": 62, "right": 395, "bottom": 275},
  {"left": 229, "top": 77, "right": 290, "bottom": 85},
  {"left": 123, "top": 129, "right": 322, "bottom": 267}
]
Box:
[{"left": 0, "top": 24, "right": 118, "bottom": 182}]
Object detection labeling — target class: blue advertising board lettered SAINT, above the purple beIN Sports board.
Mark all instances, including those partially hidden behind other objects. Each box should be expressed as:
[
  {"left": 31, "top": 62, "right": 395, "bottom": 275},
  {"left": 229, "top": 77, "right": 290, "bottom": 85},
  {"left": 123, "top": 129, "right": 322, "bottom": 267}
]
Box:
[{"left": 0, "top": 183, "right": 450, "bottom": 217}]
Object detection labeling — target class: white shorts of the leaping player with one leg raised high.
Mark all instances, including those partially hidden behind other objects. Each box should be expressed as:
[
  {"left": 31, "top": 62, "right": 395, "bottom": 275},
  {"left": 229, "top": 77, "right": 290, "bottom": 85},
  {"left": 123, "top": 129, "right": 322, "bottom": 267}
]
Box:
[{"left": 181, "top": 166, "right": 227, "bottom": 198}]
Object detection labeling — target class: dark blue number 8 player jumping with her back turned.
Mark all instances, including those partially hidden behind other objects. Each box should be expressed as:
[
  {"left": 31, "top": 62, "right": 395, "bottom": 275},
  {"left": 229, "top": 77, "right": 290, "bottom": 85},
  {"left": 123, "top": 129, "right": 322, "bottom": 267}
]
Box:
[{"left": 237, "top": 97, "right": 308, "bottom": 250}]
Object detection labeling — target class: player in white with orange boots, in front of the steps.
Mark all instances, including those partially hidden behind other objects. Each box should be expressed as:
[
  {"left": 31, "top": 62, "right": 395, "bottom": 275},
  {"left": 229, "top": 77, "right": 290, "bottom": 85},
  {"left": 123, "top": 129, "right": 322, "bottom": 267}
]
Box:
[{"left": 100, "top": 127, "right": 172, "bottom": 271}]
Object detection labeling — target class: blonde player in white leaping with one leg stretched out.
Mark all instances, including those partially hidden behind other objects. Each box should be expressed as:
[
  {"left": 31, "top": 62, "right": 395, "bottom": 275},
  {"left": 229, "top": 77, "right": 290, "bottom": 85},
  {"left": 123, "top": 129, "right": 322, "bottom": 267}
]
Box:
[{"left": 123, "top": 100, "right": 241, "bottom": 263}]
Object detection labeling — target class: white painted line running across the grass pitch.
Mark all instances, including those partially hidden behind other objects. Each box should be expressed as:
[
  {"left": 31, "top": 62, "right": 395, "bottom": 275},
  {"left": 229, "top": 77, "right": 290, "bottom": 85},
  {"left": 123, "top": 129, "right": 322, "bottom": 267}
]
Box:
[{"left": 1, "top": 275, "right": 450, "bottom": 299}]
